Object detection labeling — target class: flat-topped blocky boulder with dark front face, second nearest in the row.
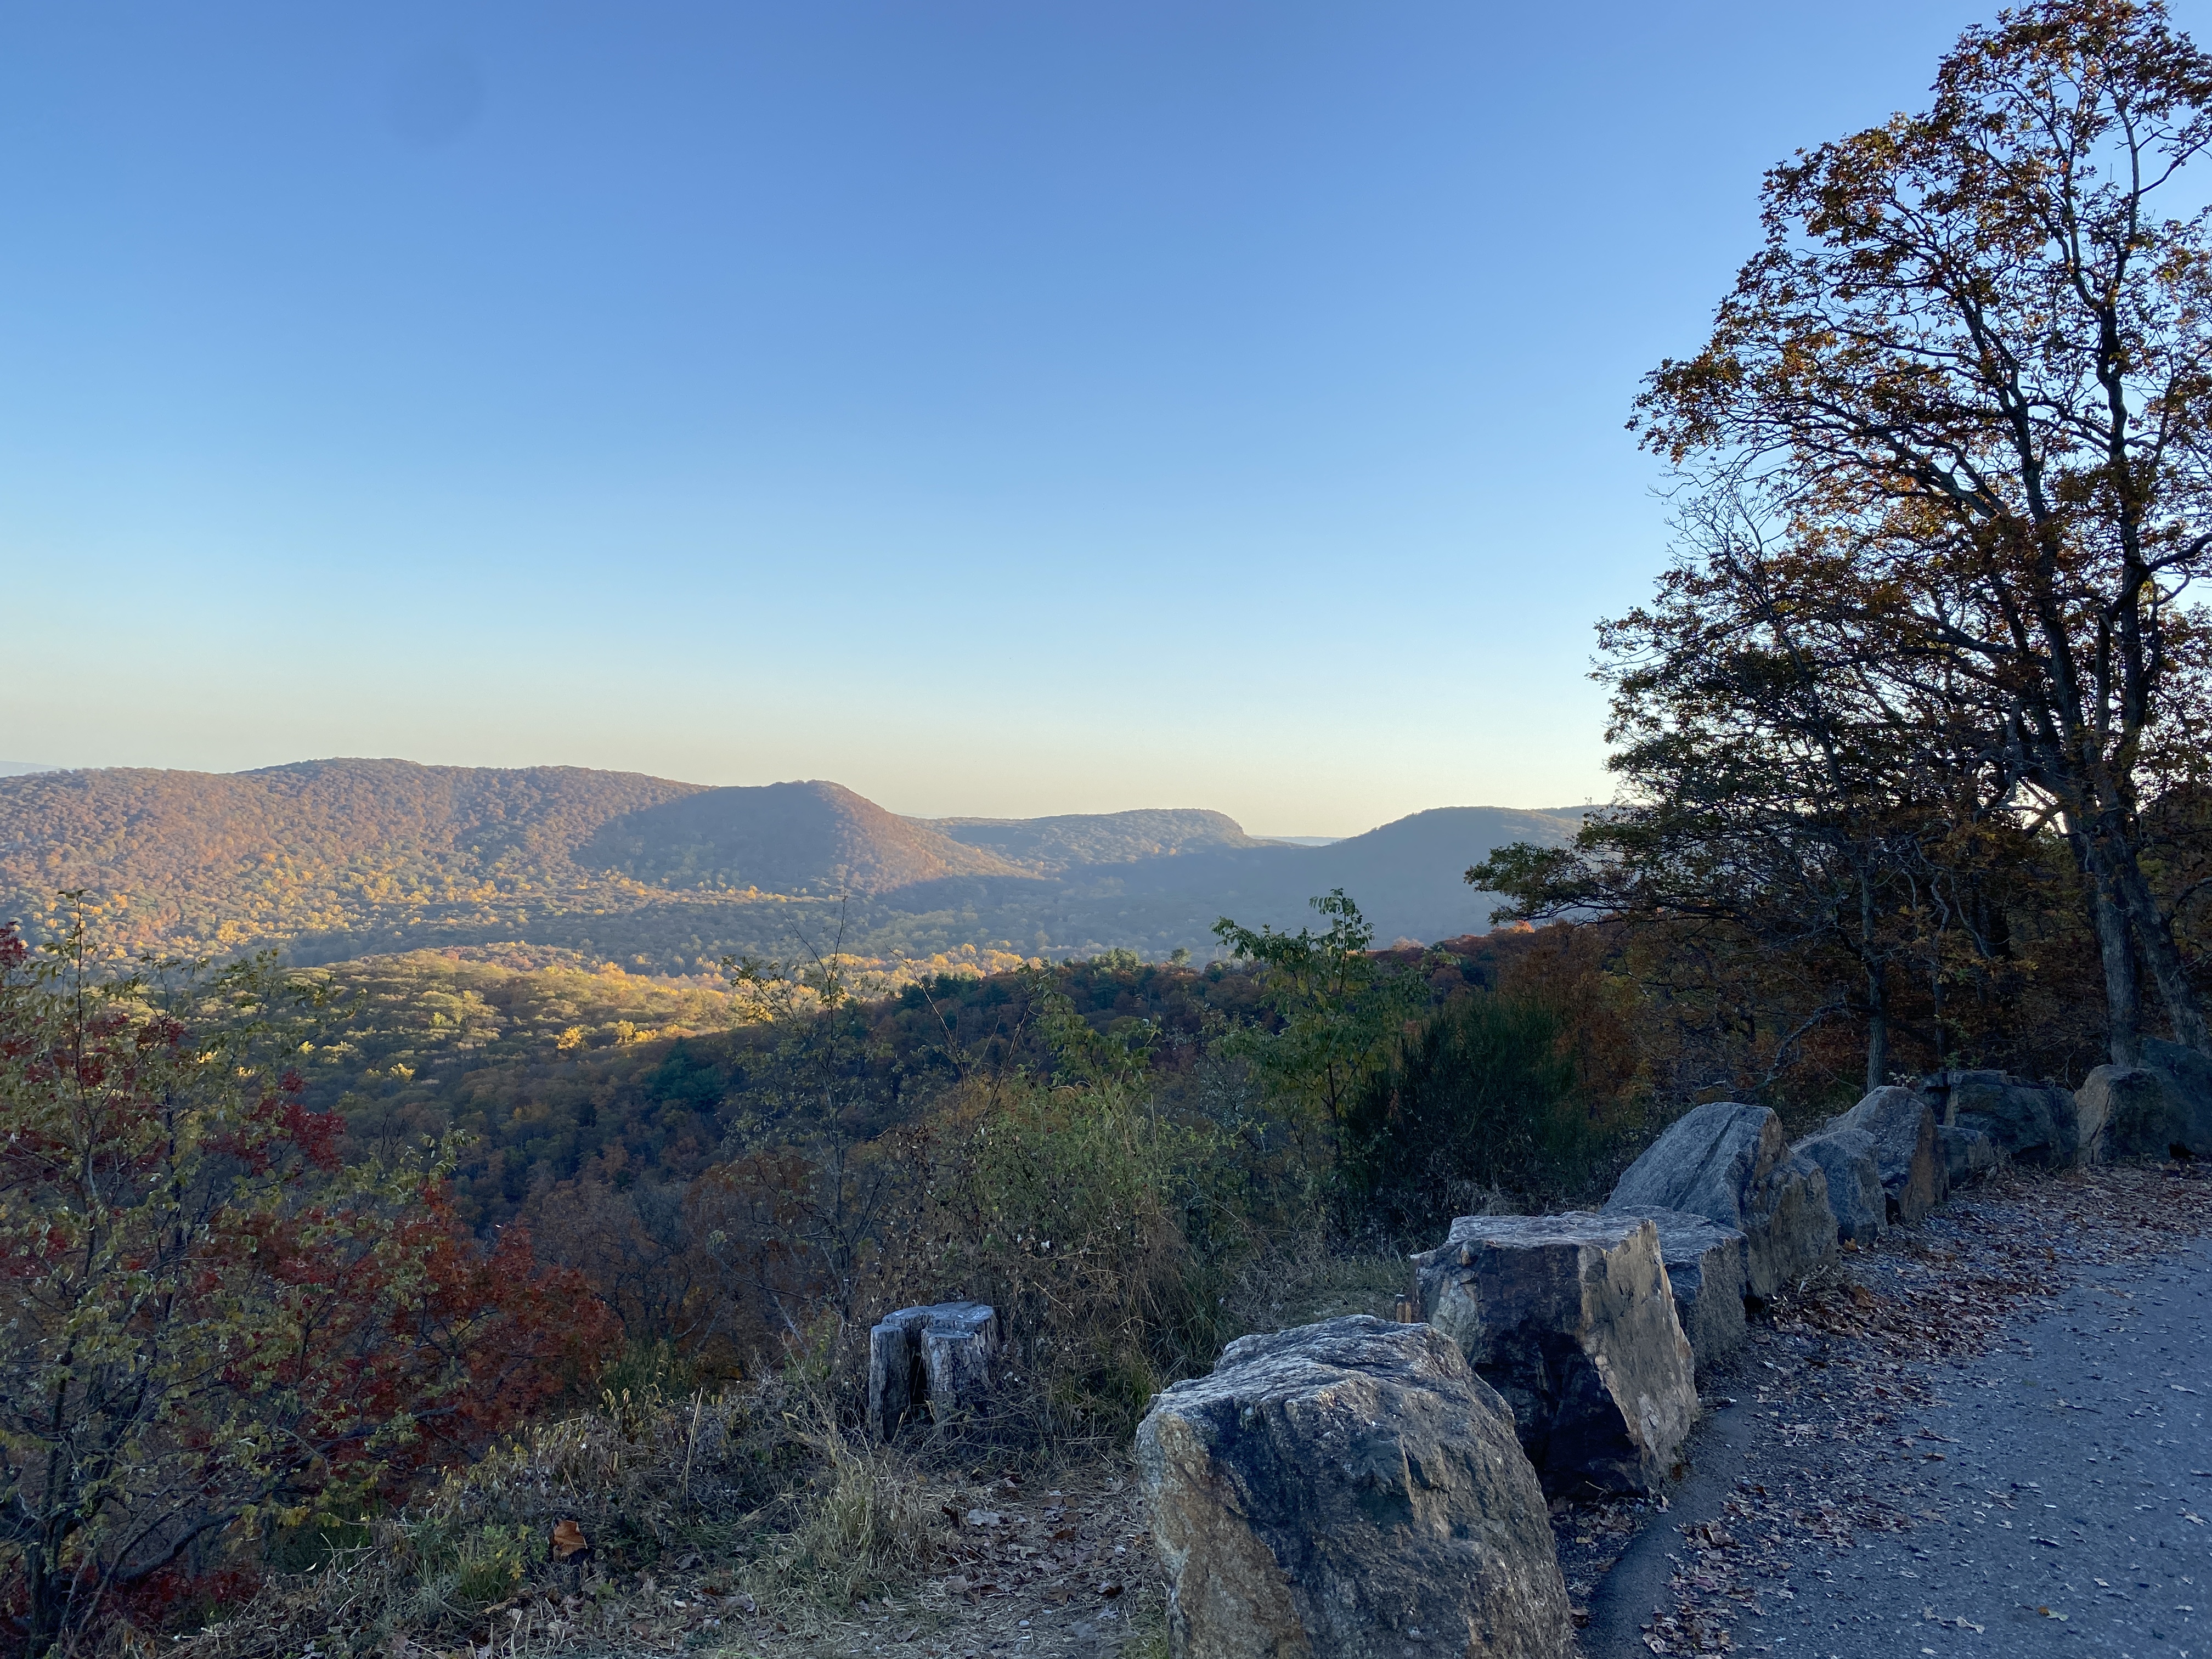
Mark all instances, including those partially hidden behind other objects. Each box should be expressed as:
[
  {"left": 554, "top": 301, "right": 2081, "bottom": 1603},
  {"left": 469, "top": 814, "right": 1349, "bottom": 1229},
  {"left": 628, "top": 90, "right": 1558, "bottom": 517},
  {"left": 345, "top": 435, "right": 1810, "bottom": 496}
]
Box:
[{"left": 1413, "top": 1212, "right": 1697, "bottom": 1491}]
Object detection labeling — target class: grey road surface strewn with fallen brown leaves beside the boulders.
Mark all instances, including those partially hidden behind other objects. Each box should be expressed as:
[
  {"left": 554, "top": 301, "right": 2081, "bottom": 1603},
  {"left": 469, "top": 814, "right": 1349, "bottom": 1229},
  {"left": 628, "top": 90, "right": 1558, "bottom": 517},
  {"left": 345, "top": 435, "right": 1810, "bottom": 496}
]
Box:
[{"left": 1582, "top": 1212, "right": 2212, "bottom": 1659}]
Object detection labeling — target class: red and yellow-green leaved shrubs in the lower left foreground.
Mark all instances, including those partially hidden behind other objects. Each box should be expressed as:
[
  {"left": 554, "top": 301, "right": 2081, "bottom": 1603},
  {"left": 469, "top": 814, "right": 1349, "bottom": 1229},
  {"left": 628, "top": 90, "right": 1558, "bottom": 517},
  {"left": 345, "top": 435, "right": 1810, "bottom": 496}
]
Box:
[{"left": 0, "top": 929, "right": 611, "bottom": 1652}]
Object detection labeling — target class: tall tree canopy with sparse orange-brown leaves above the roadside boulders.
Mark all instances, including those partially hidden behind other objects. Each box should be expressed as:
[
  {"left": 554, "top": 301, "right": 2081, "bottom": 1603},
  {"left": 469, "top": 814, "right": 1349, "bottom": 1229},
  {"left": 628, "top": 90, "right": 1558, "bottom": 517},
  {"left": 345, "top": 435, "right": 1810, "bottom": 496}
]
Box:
[{"left": 1471, "top": 0, "right": 2212, "bottom": 1080}]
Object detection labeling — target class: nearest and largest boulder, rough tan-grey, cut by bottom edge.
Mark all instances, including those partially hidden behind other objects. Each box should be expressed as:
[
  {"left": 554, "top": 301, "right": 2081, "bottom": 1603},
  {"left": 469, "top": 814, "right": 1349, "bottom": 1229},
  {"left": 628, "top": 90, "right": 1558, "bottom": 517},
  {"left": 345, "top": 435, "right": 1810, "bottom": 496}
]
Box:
[{"left": 1137, "top": 1314, "right": 1573, "bottom": 1659}]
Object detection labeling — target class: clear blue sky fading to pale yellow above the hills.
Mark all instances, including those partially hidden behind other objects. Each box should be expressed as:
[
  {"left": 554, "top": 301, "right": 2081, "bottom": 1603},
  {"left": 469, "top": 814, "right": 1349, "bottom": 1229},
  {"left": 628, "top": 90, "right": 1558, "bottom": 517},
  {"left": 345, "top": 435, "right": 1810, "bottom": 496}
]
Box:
[{"left": 0, "top": 0, "right": 2088, "bottom": 834}]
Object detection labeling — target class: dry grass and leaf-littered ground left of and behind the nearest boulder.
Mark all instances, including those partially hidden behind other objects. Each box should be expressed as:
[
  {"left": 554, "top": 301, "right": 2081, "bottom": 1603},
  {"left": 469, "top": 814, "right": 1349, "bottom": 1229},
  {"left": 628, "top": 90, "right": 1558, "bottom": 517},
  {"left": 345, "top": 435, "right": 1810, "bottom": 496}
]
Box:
[{"left": 148, "top": 1248, "right": 1404, "bottom": 1659}]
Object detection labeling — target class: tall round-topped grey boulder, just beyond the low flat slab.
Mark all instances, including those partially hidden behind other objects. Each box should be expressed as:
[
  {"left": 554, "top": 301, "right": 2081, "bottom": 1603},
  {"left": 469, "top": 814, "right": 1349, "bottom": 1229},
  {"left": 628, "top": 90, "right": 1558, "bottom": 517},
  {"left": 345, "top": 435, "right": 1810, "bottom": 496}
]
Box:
[{"left": 1606, "top": 1099, "right": 1836, "bottom": 1301}]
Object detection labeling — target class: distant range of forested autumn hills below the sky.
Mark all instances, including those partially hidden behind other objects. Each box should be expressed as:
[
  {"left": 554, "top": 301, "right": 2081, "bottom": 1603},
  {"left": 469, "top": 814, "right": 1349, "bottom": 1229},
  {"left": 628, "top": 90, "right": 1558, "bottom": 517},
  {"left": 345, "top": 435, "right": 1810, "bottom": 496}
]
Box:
[{"left": 0, "top": 761, "right": 1575, "bottom": 973}]
